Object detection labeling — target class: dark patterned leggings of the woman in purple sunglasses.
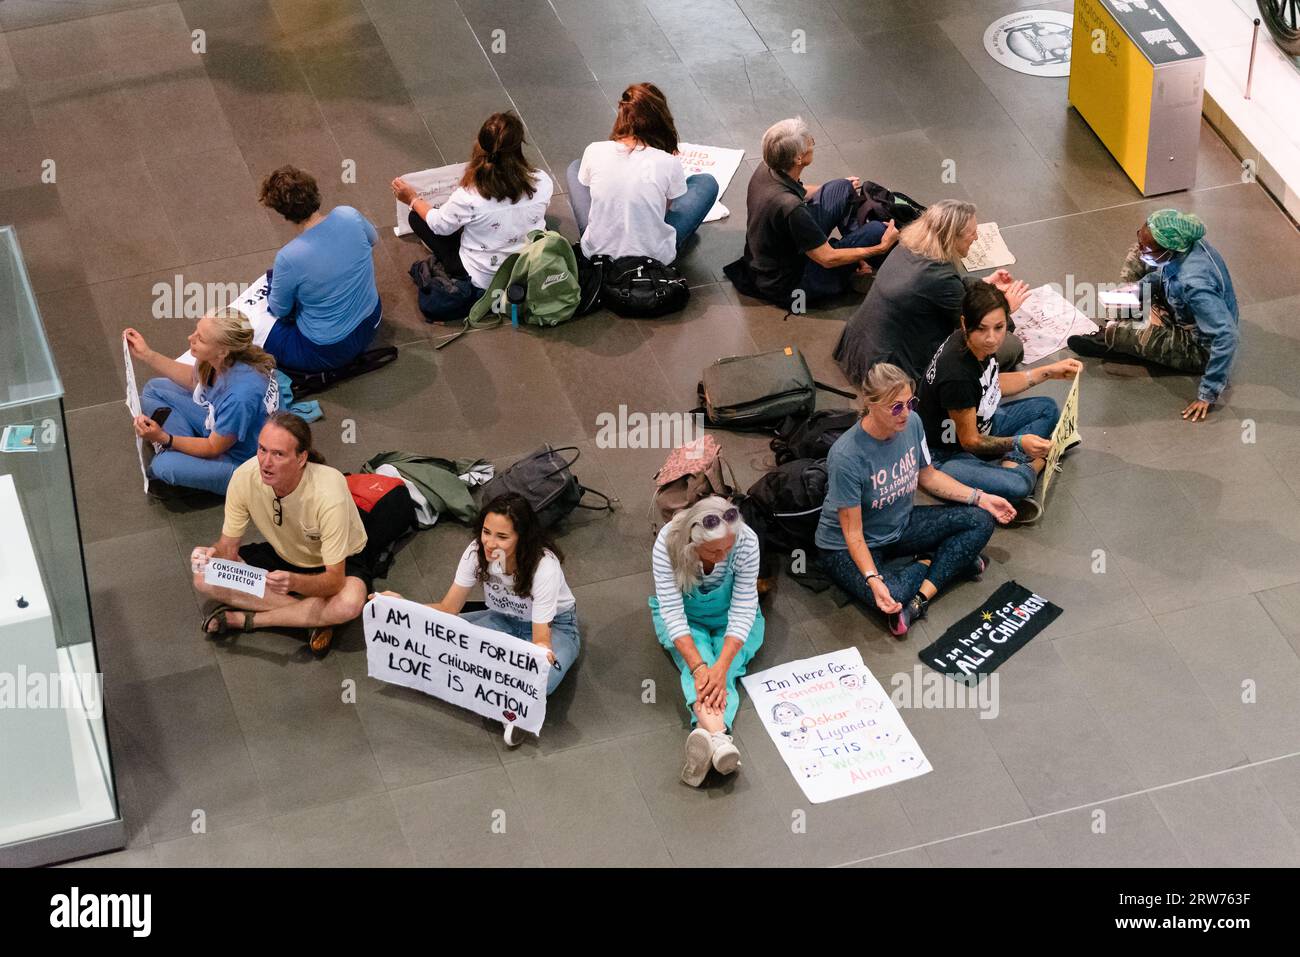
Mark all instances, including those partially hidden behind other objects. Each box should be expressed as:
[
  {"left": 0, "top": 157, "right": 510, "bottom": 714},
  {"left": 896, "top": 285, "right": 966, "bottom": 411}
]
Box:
[{"left": 818, "top": 505, "right": 995, "bottom": 609}]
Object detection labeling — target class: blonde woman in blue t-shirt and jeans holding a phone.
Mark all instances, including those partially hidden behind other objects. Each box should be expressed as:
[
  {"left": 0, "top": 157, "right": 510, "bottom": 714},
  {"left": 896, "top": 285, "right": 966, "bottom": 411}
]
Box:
[{"left": 122, "top": 307, "right": 280, "bottom": 495}]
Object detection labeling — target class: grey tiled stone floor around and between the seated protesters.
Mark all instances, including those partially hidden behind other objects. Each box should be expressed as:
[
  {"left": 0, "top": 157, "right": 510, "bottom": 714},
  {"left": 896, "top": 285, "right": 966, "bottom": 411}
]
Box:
[{"left": 0, "top": 0, "right": 1300, "bottom": 866}]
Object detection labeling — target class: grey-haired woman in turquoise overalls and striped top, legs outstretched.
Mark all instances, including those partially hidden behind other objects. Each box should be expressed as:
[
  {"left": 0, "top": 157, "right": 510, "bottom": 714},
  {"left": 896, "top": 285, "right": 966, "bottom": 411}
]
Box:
[{"left": 650, "top": 495, "right": 763, "bottom": 788}]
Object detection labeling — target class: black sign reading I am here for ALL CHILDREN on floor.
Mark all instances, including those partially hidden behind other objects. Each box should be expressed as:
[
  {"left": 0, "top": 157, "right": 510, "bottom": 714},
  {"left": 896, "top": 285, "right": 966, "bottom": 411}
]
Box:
[{"left": 918, "top": 581, "right": 1061, "bottom": 683}]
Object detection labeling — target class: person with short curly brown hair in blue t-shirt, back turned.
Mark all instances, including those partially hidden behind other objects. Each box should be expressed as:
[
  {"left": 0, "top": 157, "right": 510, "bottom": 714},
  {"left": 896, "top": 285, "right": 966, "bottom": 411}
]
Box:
[{"left": 260, "top": 166, "right": 384, "bottom": 372}]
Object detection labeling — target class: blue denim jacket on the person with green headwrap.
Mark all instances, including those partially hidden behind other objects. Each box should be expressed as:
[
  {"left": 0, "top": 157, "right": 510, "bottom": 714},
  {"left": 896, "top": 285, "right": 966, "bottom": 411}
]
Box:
[{"left": 1143, "top": 239, "right": 1242, "bottom": 402}]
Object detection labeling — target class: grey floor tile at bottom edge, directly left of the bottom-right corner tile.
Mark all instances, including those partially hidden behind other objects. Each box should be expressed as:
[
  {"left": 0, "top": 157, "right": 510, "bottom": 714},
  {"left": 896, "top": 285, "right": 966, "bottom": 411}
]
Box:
[{"left": 1036, "top": 794, "right": 1188, "bottom": 867}]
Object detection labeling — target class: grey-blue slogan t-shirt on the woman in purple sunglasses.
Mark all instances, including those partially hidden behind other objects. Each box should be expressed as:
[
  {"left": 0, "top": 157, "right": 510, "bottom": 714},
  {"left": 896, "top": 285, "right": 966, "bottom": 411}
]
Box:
[{"left": 814, "top": 413, "right": 930, "bottom": 550}]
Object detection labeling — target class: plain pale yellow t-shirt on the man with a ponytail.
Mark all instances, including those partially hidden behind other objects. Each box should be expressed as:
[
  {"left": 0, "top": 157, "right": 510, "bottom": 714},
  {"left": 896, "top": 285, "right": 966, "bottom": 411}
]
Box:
[{"left": 221, "top": 458, "right": 367, "bottom": 568}]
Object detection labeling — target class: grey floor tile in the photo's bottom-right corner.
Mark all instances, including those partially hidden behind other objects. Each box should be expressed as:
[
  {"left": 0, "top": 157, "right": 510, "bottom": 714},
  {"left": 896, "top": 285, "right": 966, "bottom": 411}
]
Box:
[{"left": 1151, "top": 768, "right": 1300, "bottom": 867}]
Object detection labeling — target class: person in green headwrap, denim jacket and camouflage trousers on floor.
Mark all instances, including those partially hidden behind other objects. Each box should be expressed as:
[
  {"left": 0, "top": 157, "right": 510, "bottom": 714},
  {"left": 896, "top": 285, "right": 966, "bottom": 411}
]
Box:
[{"left": 1066, "top": 209, "right": 1242, "bottom": 423}]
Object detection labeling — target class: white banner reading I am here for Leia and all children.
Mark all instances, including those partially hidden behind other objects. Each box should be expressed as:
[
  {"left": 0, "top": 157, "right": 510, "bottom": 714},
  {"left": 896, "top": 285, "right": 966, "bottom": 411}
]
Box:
[{"left": 361, "top": 594, "right": 551, "bottom": 735}]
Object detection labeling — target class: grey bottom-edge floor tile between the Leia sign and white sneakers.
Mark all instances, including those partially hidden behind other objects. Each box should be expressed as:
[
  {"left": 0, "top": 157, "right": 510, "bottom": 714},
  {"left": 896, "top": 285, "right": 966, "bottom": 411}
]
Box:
[{"left": 506, "top": 741, "right": 685, "bottom": 867}]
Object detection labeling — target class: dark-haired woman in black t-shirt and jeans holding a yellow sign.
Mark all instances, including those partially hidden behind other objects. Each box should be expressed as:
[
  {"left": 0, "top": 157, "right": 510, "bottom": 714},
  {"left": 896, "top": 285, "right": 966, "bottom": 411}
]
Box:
[{"left": 918, "top": 282, "right": 1083, "bottom": 521}]
